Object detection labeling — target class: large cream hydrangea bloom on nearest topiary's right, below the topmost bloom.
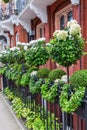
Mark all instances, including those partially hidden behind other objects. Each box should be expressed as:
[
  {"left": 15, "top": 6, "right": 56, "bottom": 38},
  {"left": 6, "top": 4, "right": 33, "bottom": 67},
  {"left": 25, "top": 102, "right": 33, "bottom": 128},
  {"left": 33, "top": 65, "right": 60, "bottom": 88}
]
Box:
[{"left": 69, "top": 24, "right": 81, "bottom": 36}]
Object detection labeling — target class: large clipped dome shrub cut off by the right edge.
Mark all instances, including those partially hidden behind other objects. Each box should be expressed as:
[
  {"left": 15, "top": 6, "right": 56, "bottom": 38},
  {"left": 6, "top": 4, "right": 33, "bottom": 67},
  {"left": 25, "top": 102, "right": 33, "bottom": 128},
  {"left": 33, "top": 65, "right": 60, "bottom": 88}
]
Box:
[{"left": 70, "top": 70, "right": 87, "bottom": 87}]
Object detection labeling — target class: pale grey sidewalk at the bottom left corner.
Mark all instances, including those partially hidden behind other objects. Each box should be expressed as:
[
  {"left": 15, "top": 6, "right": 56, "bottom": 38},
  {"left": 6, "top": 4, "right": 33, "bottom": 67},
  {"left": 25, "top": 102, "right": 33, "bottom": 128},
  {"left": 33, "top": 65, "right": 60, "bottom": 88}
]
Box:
[{"left": 0, "top": 93, "right": 26, "bottom": 130}]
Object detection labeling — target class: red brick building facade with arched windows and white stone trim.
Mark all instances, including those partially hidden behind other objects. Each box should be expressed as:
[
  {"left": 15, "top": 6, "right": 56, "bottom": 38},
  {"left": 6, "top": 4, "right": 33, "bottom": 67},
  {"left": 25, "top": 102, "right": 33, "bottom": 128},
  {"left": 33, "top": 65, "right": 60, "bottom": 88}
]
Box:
[{"left": 0, "top": 0, "right": 87, "bottom": 74}]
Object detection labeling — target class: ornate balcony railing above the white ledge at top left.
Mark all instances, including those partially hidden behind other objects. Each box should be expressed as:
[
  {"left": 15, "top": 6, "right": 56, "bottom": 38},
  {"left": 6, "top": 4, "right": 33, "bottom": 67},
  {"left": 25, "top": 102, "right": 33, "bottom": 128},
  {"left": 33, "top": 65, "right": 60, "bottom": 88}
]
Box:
[{"left": 0, "top": 0, "right": 30, "bottom": 21}]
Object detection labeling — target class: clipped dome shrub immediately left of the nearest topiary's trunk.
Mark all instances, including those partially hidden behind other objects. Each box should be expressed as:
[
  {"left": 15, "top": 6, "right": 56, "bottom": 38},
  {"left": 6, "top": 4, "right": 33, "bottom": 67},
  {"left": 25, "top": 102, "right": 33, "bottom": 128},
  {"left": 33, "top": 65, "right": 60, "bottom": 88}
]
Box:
[{"left": 49, "top": 69, "right": 66, "bottom": 80}]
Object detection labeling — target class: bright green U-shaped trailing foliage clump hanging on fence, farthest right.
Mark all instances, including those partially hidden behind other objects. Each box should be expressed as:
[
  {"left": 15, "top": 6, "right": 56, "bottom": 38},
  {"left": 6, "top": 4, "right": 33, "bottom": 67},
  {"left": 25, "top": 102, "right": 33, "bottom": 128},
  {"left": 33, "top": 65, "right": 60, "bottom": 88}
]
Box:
[{"left": 60, "top": 84, "right": 85, "bottom": 113}]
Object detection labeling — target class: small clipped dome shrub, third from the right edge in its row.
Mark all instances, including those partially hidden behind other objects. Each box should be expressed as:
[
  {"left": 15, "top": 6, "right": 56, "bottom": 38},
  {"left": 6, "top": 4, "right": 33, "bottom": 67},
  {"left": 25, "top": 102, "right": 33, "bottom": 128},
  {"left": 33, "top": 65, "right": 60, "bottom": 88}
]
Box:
[{"left": 37, "top": 68, "right": 50, "bottom": 78}]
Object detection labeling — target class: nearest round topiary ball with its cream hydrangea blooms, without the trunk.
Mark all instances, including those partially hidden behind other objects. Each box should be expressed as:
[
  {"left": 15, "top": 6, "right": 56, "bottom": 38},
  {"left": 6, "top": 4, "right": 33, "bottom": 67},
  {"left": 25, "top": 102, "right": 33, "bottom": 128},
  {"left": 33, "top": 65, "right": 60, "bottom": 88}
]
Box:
[{"left": 49, "top": 20, "right": 84, "bottom": 67}]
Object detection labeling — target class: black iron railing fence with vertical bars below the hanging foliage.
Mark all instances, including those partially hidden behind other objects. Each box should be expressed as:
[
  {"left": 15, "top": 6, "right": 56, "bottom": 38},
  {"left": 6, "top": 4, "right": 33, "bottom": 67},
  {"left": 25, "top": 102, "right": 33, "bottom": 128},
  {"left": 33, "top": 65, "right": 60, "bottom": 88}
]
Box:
[{"left": 3, "top": 76, "right": 87, "bottom": 130}]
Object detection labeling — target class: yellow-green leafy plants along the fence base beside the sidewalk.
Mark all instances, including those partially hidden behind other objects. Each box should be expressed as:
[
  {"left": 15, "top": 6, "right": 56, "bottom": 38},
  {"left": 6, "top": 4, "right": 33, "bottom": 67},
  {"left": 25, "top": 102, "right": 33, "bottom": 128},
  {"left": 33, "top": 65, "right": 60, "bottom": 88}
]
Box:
[{"left": 5, "top": 88, "right": 62, "bottom": 130}]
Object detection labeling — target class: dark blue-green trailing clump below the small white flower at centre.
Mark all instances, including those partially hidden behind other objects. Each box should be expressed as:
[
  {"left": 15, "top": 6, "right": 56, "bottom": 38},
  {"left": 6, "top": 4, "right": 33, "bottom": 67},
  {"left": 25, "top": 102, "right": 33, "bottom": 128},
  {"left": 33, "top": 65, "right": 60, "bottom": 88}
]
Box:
[{"left": 29, "top": 76, "right": 43, "bottom": 94}]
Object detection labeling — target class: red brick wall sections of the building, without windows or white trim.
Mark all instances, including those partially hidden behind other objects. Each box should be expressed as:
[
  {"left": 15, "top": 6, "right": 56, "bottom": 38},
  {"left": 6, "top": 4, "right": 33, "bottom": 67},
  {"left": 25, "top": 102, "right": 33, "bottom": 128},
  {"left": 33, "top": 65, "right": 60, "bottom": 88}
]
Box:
[{"left": 11, "top": 0, "right": 87, "bottom": 74}]
